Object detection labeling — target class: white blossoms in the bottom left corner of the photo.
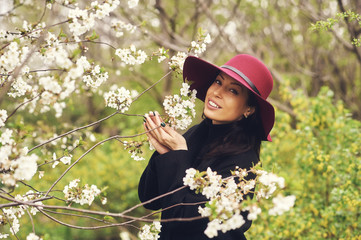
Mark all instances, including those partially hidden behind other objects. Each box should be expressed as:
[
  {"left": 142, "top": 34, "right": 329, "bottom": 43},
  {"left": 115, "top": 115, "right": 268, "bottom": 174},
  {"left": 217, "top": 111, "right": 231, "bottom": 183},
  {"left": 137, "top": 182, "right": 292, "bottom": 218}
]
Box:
[{"left": 0, "top": 190, "right": 43, "bottom": 238}]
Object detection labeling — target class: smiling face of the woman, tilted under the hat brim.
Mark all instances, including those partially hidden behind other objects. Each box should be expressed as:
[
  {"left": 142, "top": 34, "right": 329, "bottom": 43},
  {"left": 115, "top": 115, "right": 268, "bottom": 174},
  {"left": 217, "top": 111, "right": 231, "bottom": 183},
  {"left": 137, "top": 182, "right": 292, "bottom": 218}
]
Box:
[{"left": 204, "top": 73, "right": 255, "bottom": 124}]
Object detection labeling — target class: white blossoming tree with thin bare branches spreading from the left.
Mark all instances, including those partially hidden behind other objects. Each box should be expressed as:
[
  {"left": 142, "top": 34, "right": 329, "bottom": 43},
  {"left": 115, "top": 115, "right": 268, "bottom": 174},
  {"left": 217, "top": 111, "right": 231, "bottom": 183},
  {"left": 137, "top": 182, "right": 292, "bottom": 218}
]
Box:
[{"left": 0, "top": 0, "right": 295, "bottom": 239}]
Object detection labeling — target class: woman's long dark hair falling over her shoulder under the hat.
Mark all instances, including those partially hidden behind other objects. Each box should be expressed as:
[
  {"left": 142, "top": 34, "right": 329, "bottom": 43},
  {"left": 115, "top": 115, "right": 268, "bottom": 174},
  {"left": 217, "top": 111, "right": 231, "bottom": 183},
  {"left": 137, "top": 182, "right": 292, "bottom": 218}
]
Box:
[{"left": 203, "top": 91, "right": 264, "bottom": 159}]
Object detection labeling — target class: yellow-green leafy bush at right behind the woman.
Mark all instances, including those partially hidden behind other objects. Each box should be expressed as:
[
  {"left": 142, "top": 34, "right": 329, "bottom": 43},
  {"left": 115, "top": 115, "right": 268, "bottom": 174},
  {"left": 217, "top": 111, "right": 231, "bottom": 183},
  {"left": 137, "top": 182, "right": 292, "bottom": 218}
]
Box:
[{"left": 247, "top": 85, "right": 361, "bottom": 239}]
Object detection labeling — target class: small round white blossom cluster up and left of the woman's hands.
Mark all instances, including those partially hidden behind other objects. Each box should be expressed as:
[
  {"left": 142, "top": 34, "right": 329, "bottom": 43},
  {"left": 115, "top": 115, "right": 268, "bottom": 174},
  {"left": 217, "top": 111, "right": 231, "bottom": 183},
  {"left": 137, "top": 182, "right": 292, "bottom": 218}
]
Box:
[{"left": 104, "top": 85, "right": 138, "bottom": 113}]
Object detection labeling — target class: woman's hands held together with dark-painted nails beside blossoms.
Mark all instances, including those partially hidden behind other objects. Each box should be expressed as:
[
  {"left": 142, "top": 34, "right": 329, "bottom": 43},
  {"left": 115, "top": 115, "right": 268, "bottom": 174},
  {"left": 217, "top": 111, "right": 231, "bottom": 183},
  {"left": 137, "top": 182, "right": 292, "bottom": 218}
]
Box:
[{"left": 144, "top": 112, "right": 188, "bottom": 154}]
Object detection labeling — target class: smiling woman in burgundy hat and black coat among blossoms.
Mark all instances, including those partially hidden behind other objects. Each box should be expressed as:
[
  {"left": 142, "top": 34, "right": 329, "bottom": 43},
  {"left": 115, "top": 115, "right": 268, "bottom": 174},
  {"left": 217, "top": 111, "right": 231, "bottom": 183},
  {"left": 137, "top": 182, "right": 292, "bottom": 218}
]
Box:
[{"left": 138, "top": 54, "right": 274, "bottom": 240}]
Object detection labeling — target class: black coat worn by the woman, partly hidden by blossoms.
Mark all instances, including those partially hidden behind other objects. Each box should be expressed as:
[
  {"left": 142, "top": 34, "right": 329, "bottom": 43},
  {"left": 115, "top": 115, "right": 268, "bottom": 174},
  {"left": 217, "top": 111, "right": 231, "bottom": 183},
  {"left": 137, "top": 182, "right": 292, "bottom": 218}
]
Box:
[{"left": 138, "top": 120, "right": 258, "bottom": 240}]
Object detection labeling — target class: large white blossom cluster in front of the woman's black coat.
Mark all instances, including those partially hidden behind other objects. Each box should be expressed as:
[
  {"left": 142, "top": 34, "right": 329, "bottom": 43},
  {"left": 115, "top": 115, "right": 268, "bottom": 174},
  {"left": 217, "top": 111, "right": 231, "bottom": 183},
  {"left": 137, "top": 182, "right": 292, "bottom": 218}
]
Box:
[{"left": 183, "top": 168, "right": 295, "bottom": 238}]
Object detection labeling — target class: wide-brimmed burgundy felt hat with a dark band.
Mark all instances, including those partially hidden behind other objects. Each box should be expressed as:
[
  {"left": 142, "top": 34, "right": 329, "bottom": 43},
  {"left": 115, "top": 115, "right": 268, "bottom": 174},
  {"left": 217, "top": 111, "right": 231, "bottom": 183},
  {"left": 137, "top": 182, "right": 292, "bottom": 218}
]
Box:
[{"left": 183, "top": 54, "right": 275, "bottom": 141}]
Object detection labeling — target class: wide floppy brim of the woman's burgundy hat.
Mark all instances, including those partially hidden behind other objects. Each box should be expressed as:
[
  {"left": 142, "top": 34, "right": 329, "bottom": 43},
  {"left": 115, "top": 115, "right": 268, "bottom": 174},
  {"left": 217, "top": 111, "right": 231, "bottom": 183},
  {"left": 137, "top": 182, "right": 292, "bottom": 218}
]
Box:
[{"left": 183, "top": 56, "right": 275, "bottom": 141}]
